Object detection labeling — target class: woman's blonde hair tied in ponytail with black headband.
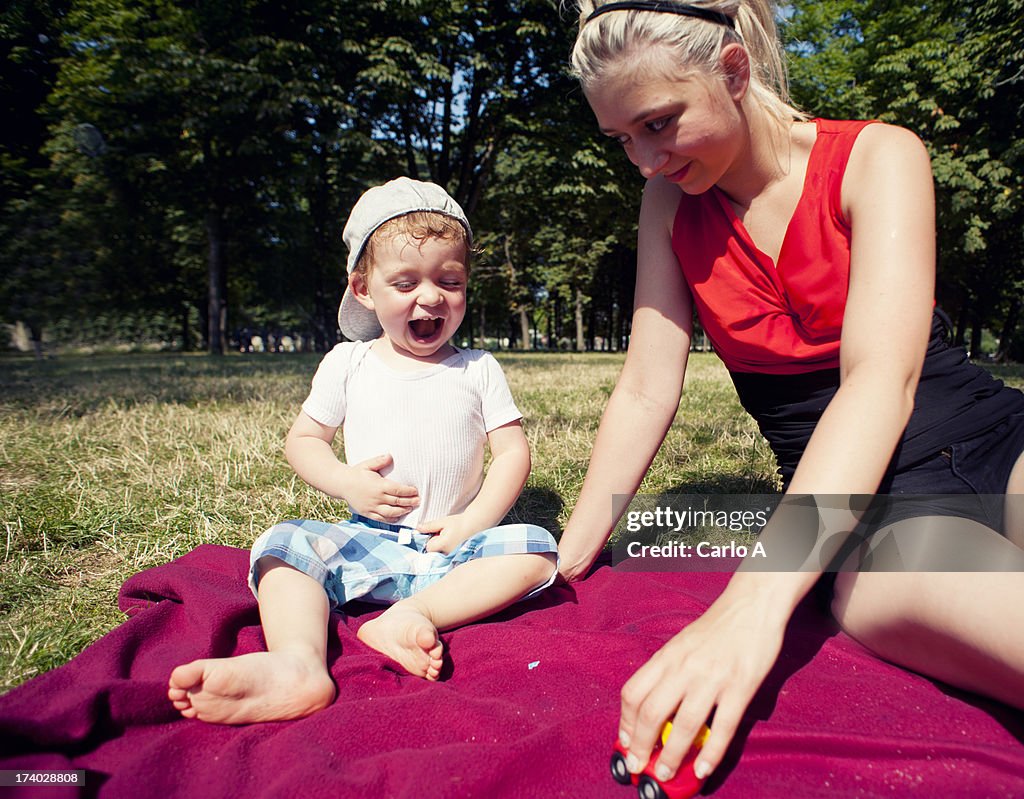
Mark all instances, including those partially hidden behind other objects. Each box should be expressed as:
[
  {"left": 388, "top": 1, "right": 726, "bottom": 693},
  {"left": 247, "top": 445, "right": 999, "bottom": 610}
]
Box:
[{"left": 571, "top": 0, "right": 807, "bottom": 122}]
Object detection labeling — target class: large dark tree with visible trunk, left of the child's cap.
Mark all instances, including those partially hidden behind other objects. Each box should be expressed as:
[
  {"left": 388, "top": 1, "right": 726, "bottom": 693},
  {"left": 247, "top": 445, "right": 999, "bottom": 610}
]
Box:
[{"left": 52, "top": 0, "right": 356, "bottom": 353}]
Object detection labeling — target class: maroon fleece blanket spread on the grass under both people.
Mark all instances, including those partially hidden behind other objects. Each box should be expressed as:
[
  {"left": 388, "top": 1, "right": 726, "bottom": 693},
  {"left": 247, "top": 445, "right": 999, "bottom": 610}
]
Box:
[{"left": 0, "top": 546, "right": 1024, "bottom": 799}]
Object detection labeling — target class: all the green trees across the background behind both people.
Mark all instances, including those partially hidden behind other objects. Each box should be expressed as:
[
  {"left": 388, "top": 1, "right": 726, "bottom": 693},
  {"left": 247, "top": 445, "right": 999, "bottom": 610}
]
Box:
[{"left": 0, "top": 0, "right": 1024, "bottom": 351}]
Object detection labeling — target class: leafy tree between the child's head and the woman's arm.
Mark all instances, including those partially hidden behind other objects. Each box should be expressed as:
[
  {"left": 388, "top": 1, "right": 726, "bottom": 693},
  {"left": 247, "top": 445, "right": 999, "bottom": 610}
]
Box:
[{"left": 478, "top": 42, "right": 642, "bottom": 350}]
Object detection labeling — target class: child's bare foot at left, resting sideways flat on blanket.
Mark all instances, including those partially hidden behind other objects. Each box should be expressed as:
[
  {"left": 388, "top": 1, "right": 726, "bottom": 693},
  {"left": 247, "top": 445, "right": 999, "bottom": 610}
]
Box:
[{"left": 167, "top": 651, "right": 335, "bottom": 724}]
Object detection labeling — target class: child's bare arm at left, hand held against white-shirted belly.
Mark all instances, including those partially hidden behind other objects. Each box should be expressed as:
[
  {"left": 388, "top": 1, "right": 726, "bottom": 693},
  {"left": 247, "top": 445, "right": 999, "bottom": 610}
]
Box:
[{"left": 285, "top": 411, "right": 419, "bottom": 521}]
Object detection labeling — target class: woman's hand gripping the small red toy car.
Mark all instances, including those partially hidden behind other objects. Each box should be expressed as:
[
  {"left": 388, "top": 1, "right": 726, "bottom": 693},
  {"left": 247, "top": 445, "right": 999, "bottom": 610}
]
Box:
[{"left": 618, "top": 588, "right": 786, "bottom": 781}]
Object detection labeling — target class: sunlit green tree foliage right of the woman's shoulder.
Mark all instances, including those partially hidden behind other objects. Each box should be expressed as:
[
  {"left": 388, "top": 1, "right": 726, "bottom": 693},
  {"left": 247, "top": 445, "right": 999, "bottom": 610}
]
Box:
[{"left": 785, "top": 0, "right": 1024, "bottom": 354}]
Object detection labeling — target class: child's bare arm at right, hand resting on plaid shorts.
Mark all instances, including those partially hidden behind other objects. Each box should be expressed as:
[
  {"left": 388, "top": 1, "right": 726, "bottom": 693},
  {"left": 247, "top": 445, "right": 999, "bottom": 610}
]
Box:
[{"left": 419, "top": 420, "right": 530, "bottom": 552}]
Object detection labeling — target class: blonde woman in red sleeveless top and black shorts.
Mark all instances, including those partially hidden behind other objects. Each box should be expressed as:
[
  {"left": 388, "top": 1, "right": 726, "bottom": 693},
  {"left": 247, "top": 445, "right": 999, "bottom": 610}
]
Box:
[{"left": 559, "top": 0, "right": 1024, "bottom": 779}]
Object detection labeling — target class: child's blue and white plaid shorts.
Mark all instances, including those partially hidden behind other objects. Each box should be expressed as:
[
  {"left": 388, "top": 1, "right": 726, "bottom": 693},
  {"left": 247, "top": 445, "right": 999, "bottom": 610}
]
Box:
[{"left": 249, "top": 515, "right": 558, "bottom": 607}]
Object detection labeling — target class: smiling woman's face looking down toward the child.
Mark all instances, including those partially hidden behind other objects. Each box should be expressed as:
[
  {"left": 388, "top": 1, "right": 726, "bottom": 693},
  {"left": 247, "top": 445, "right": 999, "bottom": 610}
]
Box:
[{"left": 586, "top": 52, "right": 742, "bottom": 195}]
